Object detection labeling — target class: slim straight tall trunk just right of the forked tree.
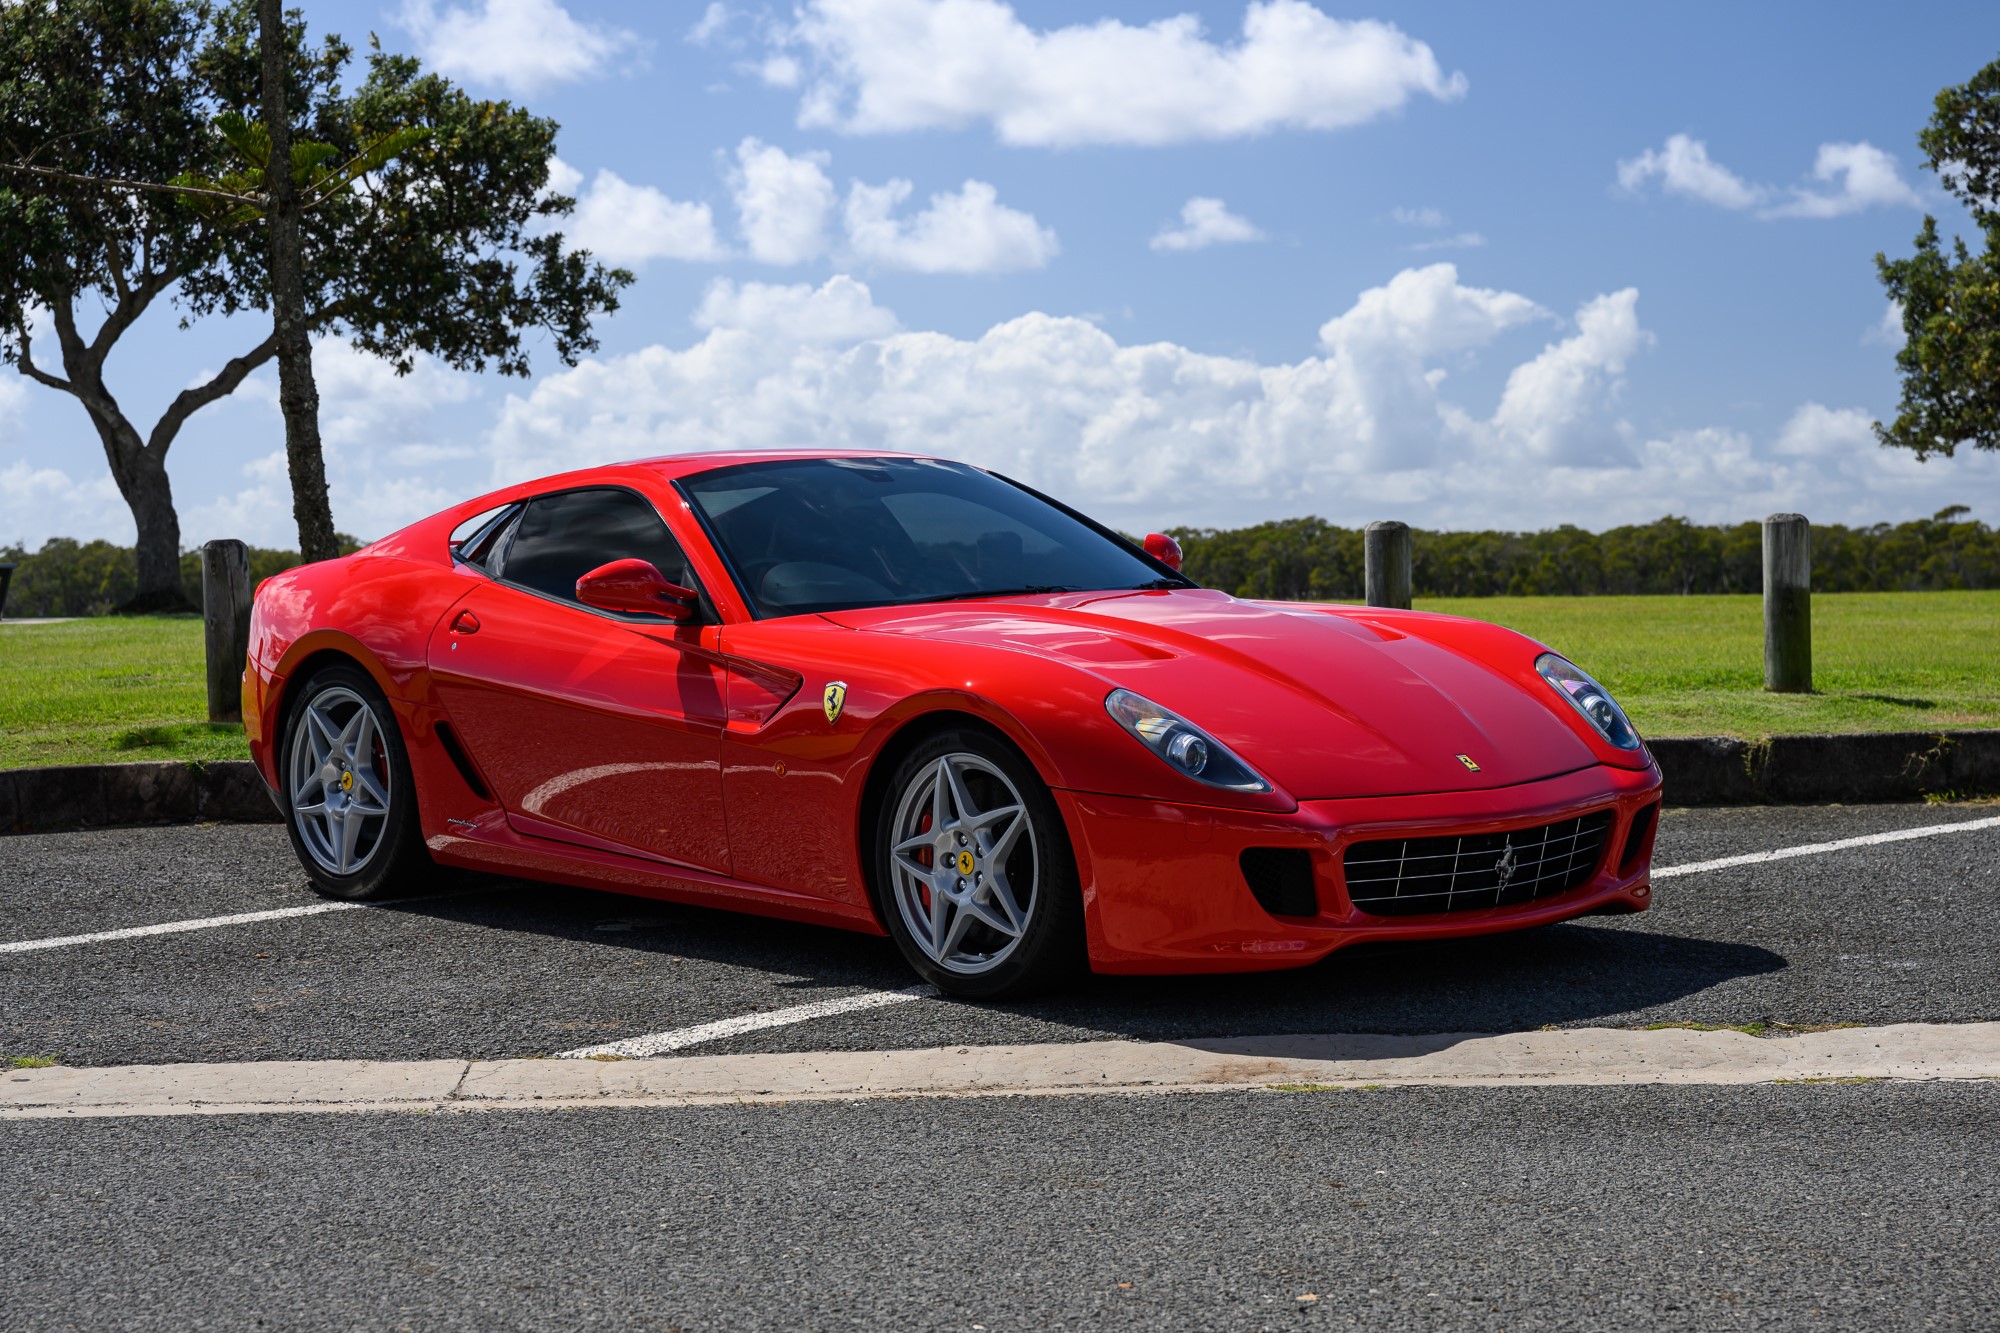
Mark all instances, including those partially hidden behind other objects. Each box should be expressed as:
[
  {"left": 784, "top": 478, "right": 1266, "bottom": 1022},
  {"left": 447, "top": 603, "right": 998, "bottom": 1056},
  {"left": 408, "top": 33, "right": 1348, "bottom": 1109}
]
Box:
[{"left": 258, "top": 0, "right": 340, "bottom": 562}]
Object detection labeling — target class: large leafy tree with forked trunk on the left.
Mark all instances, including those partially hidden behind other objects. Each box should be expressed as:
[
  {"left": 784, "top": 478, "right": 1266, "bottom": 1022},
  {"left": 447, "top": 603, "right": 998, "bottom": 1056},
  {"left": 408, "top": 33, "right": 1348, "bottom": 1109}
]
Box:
[{"left": 0, "top": 0, "right": 632, "bottom": 608}]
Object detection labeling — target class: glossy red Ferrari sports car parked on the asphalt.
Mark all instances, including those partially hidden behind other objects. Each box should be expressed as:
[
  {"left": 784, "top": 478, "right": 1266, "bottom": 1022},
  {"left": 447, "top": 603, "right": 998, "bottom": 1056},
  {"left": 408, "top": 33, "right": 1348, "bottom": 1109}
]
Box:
[{"left": 244, "top": 452, "right": 1660, "bottom": 997}]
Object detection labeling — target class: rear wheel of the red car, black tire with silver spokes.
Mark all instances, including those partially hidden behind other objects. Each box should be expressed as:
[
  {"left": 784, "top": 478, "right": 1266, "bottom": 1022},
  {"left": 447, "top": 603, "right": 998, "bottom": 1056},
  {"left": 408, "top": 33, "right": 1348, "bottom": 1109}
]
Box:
[{"left": 278, "top": 662, "right": 438, "bottom": 901}]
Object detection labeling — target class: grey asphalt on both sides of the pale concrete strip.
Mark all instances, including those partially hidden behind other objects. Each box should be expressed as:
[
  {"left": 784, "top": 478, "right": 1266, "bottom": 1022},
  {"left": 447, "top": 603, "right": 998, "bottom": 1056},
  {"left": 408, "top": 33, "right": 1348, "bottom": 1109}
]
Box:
[{"left": 0, "top": 792, "right": 2000, "bottom": 1329}]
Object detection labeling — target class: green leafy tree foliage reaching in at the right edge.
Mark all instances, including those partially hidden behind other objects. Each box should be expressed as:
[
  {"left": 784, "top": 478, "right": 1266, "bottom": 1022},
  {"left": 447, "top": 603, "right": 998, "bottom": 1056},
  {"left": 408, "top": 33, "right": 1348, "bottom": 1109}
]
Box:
[{"left": 1876, "top": 60, "right": 2000, "bottom": 458}]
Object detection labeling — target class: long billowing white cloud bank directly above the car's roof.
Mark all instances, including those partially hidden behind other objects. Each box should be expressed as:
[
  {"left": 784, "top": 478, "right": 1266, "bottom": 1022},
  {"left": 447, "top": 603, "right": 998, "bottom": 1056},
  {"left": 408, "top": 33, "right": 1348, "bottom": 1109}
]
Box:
[{"left": 476, "top": 264, "right": 1630, "bottom": 510}]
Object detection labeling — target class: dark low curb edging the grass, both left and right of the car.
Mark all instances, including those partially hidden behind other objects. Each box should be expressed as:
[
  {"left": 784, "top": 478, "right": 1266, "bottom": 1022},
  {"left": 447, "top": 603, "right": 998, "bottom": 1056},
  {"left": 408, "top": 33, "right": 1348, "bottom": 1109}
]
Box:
[{"left": 0, "top": 731, "right": 2000, "bottom": 833}]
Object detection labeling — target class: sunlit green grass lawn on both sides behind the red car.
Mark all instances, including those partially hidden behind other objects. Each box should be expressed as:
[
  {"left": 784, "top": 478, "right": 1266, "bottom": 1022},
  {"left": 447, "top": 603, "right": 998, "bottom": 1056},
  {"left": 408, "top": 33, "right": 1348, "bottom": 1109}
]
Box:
[{"left": 0, "top": 592, "right": 2000, "bottom": 769}]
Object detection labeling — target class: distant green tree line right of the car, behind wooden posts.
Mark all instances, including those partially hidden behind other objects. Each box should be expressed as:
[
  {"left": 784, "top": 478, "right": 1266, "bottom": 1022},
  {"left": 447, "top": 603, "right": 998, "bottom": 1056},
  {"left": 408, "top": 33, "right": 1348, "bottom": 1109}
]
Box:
[{"left": 1172, "top": 504, "right": 2000, "bottom": 600}]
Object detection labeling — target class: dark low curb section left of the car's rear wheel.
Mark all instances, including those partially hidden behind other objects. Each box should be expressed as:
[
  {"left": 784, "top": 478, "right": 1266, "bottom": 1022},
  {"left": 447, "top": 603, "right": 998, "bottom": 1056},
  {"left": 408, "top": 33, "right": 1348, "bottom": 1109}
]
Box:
[{"left": 0, "top": 759, "right": 278, "bottom": 833}]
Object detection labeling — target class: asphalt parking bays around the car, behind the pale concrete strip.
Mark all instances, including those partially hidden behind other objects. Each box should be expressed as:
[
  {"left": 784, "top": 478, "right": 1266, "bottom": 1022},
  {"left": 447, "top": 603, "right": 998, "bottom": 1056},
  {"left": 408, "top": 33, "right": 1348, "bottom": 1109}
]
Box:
[{"left": 0, "top": 792, "right": 2000, "bottom": 1065}]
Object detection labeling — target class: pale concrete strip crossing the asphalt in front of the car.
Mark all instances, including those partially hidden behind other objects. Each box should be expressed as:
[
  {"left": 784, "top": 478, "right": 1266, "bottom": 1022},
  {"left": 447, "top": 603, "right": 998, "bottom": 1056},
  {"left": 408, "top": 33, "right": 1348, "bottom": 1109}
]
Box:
[{"left": 0, "top": 1023, "right": 2000, "bottom": 1121}]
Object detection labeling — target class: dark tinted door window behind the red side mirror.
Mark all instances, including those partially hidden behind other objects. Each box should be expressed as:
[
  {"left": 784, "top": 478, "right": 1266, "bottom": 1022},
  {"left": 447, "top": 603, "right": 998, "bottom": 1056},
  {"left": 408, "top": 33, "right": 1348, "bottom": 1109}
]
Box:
[{"left": 500, "top": 490, "right": 692, "bottom": 602}]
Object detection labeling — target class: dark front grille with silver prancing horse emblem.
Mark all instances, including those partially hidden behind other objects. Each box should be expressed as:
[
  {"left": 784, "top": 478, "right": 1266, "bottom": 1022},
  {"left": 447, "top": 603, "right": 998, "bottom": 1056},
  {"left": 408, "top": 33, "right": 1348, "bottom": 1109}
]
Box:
[{"left": 1346, "top": 811, "right": 1612, "bottom": 917}]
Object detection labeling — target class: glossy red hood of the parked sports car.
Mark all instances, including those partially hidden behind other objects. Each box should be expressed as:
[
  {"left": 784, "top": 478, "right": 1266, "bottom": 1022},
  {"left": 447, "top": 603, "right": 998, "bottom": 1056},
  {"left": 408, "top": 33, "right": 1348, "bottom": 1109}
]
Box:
[{"left": 828, "top": 588, "right": 1616, "bottom": 801}]
